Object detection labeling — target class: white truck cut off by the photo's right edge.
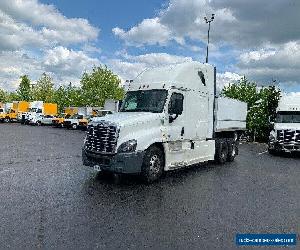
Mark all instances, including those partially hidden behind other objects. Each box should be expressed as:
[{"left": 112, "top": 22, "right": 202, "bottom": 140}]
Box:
[{"left": 268, "top": 96, "right": 300, "bottom": 154}]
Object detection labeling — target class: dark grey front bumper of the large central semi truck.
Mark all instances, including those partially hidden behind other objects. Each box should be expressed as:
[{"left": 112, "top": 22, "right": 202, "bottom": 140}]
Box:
[{"left": 82, "top": 148, "right": 144, "bottom": 174}]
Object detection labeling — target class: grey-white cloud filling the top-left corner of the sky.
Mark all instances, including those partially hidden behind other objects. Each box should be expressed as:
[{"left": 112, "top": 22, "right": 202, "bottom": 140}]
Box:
[{"left": 0, "top": 0, "right": 99, "bottom": 46}]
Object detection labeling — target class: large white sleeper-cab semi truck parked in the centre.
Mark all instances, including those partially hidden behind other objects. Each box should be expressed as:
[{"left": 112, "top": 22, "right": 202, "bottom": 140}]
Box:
[{"left": 82, "top": 62, "right": 247, "bottom": 182}]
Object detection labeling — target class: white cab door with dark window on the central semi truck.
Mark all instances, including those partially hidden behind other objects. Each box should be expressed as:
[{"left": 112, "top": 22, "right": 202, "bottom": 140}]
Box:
[{"left": 166, "top": 91, "right": 185, "bottom": 168}]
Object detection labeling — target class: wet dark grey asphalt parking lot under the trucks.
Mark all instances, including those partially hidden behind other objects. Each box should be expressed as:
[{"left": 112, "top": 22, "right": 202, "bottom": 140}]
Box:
[{"left": 0, "top": 124, "right": 300, "bottom": 249}]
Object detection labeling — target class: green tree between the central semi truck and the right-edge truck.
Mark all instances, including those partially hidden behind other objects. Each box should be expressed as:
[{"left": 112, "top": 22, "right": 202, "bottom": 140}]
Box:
[{"left": 222, "top": 77, "right": 281, "bottom": 142}]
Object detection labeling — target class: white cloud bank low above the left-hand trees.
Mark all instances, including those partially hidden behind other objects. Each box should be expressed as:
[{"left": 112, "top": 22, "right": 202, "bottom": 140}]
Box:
[{"left": 0, "top": 46, "right": 100, "bottom": 90}]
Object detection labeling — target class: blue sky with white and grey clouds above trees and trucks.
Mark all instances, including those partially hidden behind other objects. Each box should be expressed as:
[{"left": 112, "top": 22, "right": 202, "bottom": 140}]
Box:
[{"left": 0, "top": 0, "right": 300, "bottom": 92}]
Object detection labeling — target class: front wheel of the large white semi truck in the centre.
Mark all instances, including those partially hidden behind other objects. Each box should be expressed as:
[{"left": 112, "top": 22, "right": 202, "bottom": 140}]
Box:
[{"left": 141, "top": 146, "right": 165, "bottom": 183}]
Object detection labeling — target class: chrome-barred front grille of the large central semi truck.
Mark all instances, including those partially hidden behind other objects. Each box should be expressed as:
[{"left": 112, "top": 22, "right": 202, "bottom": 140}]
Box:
[{"left": 85, "top": 122, "right": 118, "bottom": 154}]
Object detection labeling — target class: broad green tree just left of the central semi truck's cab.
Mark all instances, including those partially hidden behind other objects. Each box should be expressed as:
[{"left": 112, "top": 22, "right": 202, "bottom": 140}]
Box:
[{"left": 80, "top": 66, "right": 124, "bottom": 106}]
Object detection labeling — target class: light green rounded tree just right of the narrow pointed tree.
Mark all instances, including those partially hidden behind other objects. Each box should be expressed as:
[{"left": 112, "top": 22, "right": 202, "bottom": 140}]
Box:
[{"left": 32, "top": 73, "right": 55, "bottom": 102}]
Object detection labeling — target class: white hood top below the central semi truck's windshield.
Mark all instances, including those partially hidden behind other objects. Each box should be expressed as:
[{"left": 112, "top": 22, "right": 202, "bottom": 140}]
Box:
[{"left": 92, "top": 112, "right": 162, "bottom": 127}]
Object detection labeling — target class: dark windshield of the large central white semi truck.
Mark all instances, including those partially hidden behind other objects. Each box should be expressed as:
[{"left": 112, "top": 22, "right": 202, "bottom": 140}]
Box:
[{"left": 120, "top": 89, "right": 168, "bottom": 113}]
